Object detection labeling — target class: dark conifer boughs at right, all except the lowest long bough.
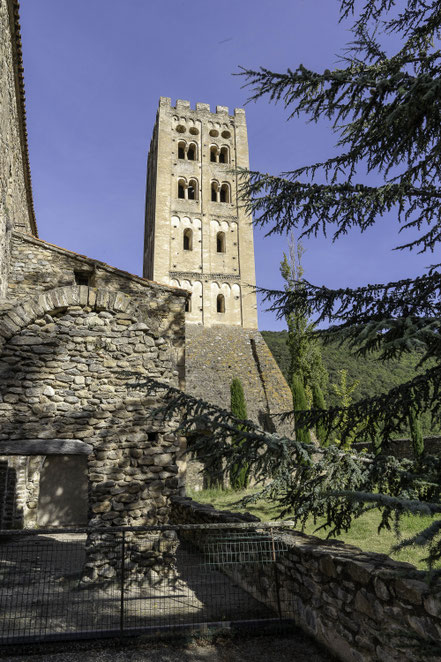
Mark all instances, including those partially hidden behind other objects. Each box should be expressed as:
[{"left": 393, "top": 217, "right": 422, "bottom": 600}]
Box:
[{"left": 242, "top": 0, "right": 441, "bottom": 446}]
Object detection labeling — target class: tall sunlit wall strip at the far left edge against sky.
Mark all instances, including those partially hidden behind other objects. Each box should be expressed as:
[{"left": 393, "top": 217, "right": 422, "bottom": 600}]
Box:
[{"left": 0, "top": 0, "right": 34, "bottom": 300}]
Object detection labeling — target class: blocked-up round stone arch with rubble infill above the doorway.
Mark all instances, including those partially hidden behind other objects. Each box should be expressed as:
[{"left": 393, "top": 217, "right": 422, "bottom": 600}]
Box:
[{"left": 0, "top": 285, "right": 182, "bottom": 544}]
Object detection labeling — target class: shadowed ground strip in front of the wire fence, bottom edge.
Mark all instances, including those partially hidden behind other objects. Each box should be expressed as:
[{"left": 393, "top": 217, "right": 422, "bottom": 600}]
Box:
[{"left": 0, "top": 631, "right": 334, "bottom": 662}]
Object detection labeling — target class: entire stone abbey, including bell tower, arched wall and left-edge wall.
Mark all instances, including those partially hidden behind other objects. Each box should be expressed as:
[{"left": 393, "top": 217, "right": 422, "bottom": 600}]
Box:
[{"left": 0, "top": 0, "right": 290, "bottom": 536}]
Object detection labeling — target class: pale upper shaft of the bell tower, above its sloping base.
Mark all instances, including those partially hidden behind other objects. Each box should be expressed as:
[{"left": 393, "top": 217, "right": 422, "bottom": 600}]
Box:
[{"left": 144, "top": 97, "right": 257, "bottom": 329}]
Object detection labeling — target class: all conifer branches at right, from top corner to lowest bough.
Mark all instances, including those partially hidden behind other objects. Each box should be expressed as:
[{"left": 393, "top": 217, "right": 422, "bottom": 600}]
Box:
[{"left": 131, "top": 0, "right": 441, "bottom": 568}]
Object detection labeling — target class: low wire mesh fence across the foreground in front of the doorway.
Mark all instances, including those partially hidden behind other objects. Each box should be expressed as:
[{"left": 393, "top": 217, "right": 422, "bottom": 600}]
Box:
[{"left": 0, "top": 525, "right": 284, "bottom": 644}]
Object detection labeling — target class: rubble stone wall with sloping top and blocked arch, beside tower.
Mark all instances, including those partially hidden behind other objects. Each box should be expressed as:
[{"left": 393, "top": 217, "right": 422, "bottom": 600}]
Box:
[{"left": 0, "top": 249, "right": 185, "bottom": 581}]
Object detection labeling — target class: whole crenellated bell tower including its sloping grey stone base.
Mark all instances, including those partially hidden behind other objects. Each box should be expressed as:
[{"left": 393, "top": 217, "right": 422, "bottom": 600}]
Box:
[{"left": 144, "top": 97, "right": 292, "bottom": 448}]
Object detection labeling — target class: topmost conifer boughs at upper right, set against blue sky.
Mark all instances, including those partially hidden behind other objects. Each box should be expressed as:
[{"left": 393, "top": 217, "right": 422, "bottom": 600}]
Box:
[{"left": 239, "top": 0, "right": 441, "bottom": 251}]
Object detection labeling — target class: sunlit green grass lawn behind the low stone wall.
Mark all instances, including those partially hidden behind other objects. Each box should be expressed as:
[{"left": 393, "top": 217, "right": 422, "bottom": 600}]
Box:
[{"left": 188, "top": 490, "right": 433, "bottom": 570}]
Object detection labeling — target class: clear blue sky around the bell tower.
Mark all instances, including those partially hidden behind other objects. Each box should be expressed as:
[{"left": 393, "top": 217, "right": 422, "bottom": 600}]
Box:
[{"left": 20, "top": 0, "right": 430, "bottom": 329}]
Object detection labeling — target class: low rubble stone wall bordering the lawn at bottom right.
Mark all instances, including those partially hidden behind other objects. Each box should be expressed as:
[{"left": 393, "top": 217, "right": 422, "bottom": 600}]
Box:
[{"left": 171, "top": 497, "right": 441, "bottom": 662}]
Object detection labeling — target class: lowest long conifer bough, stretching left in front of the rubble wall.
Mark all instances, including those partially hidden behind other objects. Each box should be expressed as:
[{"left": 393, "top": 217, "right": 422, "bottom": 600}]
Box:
[{"left": 130, "top": 374, "right": 441, "bottom": 574}]
